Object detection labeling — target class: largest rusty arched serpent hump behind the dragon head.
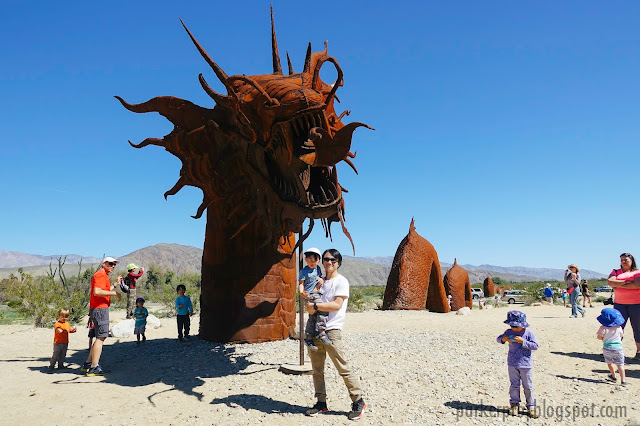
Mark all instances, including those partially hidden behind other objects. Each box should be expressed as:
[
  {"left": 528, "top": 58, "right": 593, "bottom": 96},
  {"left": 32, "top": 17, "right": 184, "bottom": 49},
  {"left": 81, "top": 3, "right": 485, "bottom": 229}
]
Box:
[{"left": 382, "top": 219, "right": 449, "bottom": 312}]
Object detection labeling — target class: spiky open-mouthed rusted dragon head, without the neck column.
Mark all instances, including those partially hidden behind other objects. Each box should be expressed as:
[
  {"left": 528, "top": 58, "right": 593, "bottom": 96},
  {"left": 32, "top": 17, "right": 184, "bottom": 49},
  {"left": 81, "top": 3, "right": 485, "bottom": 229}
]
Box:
[{"left": 116, "top": 10, "right": 371, "bottom": 251}]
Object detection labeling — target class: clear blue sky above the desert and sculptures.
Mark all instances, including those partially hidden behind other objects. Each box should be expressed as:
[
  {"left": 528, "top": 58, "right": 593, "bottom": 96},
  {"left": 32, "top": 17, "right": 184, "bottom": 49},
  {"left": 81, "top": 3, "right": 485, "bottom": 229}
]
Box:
[{"left": 0, "top": 0, "right": 640, "bottom": 272}]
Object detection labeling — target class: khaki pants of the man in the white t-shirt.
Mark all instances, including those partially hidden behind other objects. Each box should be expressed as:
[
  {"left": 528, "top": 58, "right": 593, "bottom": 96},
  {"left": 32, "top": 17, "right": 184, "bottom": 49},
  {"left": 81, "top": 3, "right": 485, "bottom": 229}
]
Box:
[{"left": 309, "top": 330, "right": 362, "bottom": 402}]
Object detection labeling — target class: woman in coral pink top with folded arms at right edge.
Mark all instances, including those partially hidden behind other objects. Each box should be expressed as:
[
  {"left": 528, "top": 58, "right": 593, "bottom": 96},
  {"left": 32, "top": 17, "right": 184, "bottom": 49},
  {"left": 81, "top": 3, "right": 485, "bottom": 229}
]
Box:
[{"left": 608, "top": 253, "right": 640, "bottom": 361}]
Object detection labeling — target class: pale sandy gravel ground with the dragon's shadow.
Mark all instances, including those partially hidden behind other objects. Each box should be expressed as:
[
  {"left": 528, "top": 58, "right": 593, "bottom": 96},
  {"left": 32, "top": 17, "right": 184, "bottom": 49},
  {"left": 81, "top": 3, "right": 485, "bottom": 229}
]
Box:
[{"left": 0, "top": 304, "right": 640, "bottom": 425}]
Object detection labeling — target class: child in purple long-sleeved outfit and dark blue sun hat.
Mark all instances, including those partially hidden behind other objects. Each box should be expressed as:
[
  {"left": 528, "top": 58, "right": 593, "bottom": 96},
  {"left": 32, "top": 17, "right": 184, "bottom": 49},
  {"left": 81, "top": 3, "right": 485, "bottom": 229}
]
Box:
[{"left": 497, "top": 311, "right": 540, "bottom": 419}]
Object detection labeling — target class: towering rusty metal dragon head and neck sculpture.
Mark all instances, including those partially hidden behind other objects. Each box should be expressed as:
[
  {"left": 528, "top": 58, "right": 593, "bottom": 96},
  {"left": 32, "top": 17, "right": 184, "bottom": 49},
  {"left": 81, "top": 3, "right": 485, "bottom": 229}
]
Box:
[{"left": 116, "top": 12, "right": 370, "bottom": 343}]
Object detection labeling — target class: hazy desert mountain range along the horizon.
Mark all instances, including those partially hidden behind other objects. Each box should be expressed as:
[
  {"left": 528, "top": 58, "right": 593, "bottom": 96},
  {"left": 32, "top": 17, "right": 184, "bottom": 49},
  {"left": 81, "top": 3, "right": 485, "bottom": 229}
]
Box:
[{"left": 0, "top": 243, "right": 604, "bottom": 286}]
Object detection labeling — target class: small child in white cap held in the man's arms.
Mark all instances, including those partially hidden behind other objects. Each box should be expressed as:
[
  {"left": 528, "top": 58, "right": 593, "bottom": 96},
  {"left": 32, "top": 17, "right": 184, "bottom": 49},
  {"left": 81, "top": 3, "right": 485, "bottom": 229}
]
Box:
[{"left": 298, "top": 247, "right": 331, "bottom": 351}]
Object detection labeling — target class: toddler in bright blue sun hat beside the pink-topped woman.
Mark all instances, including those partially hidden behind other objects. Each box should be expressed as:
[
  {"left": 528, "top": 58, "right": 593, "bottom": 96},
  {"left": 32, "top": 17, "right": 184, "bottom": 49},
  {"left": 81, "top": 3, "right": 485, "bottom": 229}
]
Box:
[{"left": 596, "top": 308, "right": 627, "bottom": 386}]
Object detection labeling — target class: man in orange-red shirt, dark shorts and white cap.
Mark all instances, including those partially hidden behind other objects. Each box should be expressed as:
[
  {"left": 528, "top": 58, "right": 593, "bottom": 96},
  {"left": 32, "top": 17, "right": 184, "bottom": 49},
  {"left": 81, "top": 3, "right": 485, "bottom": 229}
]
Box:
[{"left": 81, "top": 257, "right": 124, "bottom": 376}]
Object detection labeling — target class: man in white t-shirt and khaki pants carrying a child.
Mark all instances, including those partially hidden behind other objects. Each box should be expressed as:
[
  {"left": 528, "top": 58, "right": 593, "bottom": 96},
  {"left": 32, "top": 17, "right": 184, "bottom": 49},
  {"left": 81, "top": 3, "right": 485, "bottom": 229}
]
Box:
[{"left": 306, "top": 249, "right": 367, "bottom": 420}]
